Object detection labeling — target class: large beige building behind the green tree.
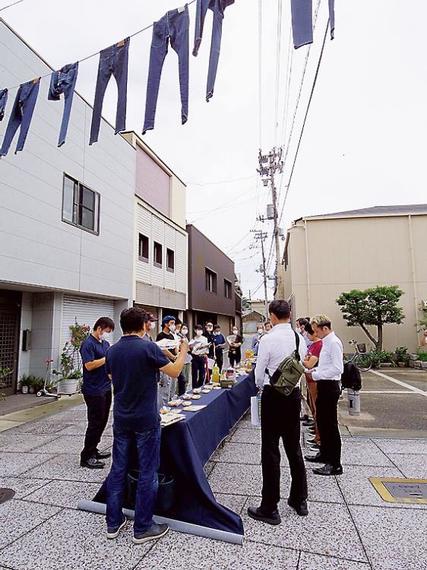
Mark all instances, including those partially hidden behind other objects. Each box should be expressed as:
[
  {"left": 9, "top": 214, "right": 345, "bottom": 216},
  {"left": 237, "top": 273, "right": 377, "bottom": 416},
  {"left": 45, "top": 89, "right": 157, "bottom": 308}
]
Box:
[{"left": 277, "top": 204, "right": 427, "bottom": 352}]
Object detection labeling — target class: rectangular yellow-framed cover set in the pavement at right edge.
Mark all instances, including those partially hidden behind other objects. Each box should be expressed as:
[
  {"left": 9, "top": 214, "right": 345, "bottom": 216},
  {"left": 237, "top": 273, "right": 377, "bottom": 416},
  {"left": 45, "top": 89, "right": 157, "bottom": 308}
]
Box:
[{"left": 369, "top": 477, "right": 427, "bottom": 504}]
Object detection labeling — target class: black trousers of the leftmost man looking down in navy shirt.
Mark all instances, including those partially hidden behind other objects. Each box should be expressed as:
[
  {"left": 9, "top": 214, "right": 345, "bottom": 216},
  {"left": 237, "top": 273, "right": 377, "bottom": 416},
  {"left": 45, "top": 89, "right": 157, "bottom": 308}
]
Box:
[{"left": 80, "top": 390, "right": 111, "bottom": 461}]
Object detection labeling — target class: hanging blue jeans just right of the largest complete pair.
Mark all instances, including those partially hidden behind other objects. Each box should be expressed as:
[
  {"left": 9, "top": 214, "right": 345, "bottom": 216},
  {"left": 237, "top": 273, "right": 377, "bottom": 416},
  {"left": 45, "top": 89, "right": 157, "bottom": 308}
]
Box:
[{"left": 193, "top": 0, "right": 234, "bottom": 101}]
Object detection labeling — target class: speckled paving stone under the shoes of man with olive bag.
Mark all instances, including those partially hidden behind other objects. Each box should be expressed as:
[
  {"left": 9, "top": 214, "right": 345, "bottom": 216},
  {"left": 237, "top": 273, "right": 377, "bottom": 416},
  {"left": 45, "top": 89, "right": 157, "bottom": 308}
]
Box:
[{"left": 242, "top": 497, "right": 366, "bottom": 562}]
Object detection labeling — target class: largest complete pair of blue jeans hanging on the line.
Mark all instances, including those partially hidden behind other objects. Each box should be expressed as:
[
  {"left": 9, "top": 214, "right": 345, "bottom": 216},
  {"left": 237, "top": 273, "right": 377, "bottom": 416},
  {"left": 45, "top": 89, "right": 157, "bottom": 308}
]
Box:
[{"left": 143, "top": 5, "right": 190, "bottom": 134}]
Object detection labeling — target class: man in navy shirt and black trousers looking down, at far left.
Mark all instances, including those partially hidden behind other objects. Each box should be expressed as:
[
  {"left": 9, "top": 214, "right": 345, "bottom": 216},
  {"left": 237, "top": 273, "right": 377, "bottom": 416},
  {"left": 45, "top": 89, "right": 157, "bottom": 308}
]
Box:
[{"left": 80, "top": 317, "right": 114, "bottom": 469}]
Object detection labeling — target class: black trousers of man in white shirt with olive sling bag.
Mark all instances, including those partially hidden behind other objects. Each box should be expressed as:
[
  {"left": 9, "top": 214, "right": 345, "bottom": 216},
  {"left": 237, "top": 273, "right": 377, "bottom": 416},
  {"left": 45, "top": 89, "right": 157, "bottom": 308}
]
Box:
[{"left": 261, "top": 386, "right": 307, "bottom": 514}]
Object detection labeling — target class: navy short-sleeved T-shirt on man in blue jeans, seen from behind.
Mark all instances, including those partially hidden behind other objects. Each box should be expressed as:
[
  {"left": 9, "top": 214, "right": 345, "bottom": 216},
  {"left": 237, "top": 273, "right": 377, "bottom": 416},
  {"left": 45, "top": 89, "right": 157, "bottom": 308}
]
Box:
[{"left": 106, "top": 335, "right": 169, "bottom": 433}]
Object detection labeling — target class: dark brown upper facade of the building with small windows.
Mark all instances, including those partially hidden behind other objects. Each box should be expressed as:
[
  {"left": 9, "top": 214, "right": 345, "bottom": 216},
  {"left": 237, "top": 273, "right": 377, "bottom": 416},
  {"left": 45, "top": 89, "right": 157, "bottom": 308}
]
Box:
[{"left": 187, "top": 225, "right": 235, "bottom": 317}]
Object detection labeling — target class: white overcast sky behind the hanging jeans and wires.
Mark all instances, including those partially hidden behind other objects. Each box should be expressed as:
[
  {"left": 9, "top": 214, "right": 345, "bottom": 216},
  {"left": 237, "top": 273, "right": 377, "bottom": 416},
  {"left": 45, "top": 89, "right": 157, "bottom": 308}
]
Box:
[{"left": 0, "top": 0, "right": 427, "bottom": 298}]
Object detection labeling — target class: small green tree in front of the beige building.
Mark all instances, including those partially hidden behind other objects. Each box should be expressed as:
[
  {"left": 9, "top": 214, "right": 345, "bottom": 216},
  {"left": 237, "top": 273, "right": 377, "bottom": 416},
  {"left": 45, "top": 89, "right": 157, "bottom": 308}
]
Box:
[{"left": 337, "top": 285, "right": 405, "bottom": 351}]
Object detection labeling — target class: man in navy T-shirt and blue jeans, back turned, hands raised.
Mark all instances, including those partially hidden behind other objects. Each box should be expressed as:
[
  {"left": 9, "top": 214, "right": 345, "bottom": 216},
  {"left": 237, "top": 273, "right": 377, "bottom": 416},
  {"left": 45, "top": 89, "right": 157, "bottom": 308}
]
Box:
[{"left": 106, "top": 307, "right": 188, "bottom": 544}]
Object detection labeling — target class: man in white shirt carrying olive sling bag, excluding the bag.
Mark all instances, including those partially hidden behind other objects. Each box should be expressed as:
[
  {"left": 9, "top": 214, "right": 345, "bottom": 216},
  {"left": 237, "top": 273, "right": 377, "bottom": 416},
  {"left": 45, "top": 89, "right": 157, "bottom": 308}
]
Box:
[{"left": 248, "top": 300, "right": 308, "bottom": 525}]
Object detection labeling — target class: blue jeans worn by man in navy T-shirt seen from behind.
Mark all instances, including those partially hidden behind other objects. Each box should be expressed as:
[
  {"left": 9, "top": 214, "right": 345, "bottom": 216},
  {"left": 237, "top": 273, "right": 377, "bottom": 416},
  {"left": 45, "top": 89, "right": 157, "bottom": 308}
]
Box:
[{"left": 106, "top": 424, "right": 160, "bottom": 534}]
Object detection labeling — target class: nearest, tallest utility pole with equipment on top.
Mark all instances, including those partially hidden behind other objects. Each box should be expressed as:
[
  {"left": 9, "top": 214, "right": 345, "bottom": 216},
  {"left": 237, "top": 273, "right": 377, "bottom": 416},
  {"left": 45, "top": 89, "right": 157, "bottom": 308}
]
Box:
[{"left": 257, "top": 147, "right": 283, "bottom": 294}]
